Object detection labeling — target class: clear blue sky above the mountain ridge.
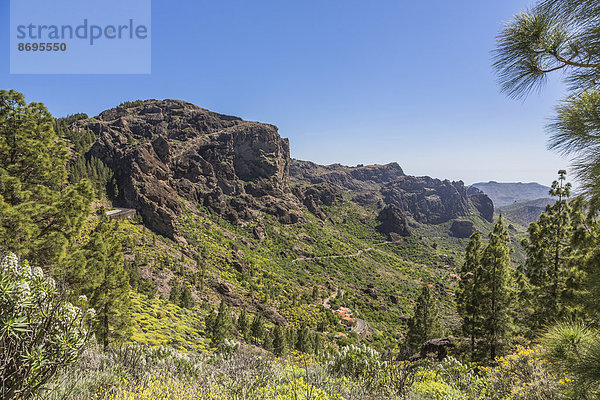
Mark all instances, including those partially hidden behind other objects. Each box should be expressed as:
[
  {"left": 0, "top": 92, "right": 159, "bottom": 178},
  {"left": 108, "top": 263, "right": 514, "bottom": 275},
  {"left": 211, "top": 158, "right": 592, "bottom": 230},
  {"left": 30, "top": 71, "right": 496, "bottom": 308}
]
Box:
[{"left": 0, "top": 0, "right": 568, "bottom": 184}]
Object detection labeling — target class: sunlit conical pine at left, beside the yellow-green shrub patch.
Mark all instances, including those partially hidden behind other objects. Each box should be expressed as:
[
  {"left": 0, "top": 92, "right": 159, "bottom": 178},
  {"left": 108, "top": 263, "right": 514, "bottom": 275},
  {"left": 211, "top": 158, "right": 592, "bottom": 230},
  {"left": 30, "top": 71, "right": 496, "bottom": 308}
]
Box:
[{"left": 83, "top": 214, "right": 131, "bottom": 349}]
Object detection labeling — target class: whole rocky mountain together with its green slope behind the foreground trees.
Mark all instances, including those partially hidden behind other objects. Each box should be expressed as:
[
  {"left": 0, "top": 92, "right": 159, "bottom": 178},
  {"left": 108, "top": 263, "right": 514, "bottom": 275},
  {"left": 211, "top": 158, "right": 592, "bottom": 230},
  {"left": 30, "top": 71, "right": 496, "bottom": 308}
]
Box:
[{"left": 65, "top": 100, "right": 502, "bottom": 346}]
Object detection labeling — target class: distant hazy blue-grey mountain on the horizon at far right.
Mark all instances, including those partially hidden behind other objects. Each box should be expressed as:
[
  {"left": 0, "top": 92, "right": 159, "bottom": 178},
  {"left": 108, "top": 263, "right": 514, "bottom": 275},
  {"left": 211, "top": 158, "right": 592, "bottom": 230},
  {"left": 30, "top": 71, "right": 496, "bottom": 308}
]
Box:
[{"left": 471, "top": 181, "right": 550, "bottom": 207}]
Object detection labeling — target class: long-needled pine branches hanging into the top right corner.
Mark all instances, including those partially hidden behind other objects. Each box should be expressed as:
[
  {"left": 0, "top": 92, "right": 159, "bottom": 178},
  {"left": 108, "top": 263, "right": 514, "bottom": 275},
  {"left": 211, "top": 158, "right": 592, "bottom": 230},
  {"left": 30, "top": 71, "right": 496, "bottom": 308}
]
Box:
[{"left": 494, "top": 0, "right": 600, "bottom": 201}]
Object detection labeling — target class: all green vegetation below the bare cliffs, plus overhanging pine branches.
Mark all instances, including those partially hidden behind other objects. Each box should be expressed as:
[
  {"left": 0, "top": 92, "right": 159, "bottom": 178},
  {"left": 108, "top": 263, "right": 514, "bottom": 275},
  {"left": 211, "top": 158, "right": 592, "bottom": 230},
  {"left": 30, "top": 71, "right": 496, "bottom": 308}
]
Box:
[{"left": 0, "top": 0, "right": 600, "bottom": 400}]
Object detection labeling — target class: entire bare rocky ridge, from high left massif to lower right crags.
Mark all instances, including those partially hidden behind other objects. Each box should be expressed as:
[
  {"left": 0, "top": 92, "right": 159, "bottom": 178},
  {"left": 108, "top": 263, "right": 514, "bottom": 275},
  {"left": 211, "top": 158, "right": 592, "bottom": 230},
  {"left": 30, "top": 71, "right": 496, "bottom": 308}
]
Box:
[{"left": 73, "top": 100, "right": 493, "bottom": 244}]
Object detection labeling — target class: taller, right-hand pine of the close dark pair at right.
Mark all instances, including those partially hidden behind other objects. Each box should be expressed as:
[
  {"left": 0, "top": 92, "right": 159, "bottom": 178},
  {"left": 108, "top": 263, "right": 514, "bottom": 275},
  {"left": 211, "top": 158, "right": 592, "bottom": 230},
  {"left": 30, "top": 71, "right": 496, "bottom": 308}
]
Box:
[{"left": 480, "top": 217, "right": 512, "bottom": 360}]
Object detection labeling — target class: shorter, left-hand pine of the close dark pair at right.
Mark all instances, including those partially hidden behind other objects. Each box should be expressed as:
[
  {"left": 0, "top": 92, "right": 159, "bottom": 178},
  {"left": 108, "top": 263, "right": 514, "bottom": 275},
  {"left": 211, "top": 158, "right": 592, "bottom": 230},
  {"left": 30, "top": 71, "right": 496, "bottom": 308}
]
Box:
[{"left": 456, "top": 232, "right": 483, "bottom": 359}]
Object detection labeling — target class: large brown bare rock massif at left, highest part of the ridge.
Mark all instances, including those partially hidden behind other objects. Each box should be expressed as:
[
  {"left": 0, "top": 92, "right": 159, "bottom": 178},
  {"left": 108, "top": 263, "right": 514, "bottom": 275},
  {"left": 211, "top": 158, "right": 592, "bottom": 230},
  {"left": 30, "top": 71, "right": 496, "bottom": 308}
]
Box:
[{"left": 74, "top": 100, "right": 302, "bottom": 239}]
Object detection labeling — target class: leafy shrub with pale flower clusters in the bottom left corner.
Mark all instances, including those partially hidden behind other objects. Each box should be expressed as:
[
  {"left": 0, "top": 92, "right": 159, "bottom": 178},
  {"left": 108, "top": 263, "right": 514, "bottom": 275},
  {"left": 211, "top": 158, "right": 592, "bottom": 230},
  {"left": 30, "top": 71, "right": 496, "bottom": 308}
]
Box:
[{"left": 0, "top": 254, "right": 91, "bottom": 400}]
